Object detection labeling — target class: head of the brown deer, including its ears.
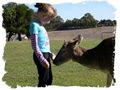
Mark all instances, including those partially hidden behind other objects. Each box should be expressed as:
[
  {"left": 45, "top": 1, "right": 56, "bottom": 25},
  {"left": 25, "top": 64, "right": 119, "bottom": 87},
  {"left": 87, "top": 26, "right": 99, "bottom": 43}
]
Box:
[{"left": 53, "top": 35, "right": 83, "bottom": 65}]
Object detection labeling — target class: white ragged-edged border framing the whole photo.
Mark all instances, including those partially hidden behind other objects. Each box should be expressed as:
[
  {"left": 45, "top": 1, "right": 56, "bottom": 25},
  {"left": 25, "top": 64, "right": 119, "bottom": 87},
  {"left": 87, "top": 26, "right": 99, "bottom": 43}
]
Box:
[{"left": 0, "top": 0, "right": 120, "bottom": 90}]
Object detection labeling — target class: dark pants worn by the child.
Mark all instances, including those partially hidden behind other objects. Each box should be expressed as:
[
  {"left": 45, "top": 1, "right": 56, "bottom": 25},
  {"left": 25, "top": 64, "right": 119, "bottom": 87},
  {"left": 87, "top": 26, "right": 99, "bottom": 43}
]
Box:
[{"left": 33, "top": 53, "right": 53, "bottom": 87}]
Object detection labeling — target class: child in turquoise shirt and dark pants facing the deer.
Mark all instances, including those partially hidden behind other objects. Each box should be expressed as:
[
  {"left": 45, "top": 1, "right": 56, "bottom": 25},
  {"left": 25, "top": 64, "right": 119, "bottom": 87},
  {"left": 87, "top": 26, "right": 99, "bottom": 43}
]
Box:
[{"left": 30, "top": 3, "right": 57, "bottom": 87}]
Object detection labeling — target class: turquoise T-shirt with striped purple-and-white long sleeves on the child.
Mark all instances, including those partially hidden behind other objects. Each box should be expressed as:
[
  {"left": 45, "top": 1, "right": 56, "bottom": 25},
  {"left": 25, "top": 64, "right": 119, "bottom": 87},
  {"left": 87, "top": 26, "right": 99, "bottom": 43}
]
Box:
[{"left": 30, "top": 21, "right": 52, "bottom": 64}]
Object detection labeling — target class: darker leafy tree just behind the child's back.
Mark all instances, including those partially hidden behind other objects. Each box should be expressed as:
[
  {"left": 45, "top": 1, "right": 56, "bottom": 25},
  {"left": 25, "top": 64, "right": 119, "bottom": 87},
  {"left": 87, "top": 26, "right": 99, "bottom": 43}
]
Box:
[{"left": 16, "top": 4, "right": 33, "bottom": 40}]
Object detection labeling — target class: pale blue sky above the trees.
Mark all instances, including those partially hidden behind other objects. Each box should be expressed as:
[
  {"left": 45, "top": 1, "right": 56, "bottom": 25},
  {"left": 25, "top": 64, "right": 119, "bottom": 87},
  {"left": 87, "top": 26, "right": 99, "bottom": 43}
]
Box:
[{"left": 26, "top": 1, "right": 116, "bottom": 21}]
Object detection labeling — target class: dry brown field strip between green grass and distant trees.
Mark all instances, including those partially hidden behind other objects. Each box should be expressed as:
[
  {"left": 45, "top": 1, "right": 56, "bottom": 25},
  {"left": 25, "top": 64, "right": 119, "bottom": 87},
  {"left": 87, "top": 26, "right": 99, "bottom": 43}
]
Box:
[{"left": 48, "top": 27, "right": 116, "bottom": 40}]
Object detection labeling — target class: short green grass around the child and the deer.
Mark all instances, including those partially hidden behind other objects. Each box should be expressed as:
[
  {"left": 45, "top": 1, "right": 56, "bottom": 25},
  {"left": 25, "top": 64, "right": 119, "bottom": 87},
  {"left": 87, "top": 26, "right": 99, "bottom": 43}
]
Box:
[{"left": 3, "top": 41, "right": 106, "bottom": 88}]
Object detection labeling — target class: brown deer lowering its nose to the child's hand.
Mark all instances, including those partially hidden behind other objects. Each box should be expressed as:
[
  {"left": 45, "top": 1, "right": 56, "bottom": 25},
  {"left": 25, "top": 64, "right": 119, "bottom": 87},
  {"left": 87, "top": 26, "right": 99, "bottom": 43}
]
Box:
[{"left": 53, "top": 35, "right": 115, "bottom": 87}]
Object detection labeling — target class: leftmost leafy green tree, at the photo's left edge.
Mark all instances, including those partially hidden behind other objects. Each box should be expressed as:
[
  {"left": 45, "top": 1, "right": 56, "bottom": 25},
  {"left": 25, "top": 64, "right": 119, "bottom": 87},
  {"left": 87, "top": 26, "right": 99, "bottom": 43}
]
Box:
[{"left": 2, "top": 2, "right": 17, "bottom": 41}]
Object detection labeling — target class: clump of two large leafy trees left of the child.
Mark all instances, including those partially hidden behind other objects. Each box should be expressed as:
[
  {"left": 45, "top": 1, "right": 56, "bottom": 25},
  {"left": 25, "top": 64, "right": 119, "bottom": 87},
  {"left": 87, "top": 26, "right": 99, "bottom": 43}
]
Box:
[{"left": 3, "top": 2, "right": 34, "bottom": 41}]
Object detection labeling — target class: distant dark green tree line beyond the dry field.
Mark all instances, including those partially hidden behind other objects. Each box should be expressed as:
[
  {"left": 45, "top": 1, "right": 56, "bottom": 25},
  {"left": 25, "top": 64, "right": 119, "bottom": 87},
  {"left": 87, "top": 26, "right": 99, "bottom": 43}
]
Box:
[{"left": 45, "top": 13, "right": 116, "bottom": 30}]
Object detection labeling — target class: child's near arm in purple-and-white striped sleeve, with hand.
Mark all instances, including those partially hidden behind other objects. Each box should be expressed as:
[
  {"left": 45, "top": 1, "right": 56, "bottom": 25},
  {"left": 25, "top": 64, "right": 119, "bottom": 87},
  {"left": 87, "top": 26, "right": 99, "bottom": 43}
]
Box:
[{"left": 30, "top": 34, "right": 49, "bottom": 68}]
